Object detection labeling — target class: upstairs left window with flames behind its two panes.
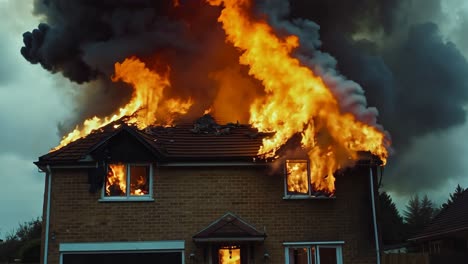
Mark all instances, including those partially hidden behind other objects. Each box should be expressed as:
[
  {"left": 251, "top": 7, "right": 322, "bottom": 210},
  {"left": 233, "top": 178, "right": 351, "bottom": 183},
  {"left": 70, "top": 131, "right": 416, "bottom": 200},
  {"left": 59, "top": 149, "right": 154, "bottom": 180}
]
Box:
[{"left": 103, "top": 163, "right": 152, "bottom": 200}]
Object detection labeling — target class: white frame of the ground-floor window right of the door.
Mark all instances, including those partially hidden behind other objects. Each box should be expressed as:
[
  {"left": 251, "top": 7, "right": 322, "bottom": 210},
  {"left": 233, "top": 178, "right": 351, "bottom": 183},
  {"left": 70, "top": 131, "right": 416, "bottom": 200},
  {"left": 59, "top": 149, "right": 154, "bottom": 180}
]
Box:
[{"left": 283, "top": 241, "right": 344, "bottom": 264}]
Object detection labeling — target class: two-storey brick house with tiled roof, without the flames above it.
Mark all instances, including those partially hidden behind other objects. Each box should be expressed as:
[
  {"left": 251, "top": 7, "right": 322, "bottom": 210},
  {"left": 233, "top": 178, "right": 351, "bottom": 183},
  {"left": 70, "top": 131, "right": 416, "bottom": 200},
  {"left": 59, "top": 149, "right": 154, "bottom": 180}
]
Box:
[{"left": 36, "top": 115, "right": 381, "bottom": 264}]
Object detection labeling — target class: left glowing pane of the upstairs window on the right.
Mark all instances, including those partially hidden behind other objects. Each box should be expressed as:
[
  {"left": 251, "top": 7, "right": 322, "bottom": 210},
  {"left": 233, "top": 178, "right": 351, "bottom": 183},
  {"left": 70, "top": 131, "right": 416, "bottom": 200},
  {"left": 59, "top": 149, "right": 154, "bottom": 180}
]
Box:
[{"left": 286, "top": 160, "right": 309, "bottom": 194}]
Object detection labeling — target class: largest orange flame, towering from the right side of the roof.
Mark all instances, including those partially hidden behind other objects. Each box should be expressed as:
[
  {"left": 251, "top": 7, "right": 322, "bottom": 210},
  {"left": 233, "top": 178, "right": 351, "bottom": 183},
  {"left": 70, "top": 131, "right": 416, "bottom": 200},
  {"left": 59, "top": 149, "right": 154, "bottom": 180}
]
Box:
[{"left": 208, "top": 0, "right": 388, "bottom": 192}]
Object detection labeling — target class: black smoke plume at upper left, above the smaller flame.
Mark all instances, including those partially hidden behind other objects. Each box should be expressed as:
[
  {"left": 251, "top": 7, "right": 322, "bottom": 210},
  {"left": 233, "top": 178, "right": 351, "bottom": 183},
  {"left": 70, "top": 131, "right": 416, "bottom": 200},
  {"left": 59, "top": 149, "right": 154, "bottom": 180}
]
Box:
[{"left": 21, "top": 0, "right": 189, "bottom": 83}]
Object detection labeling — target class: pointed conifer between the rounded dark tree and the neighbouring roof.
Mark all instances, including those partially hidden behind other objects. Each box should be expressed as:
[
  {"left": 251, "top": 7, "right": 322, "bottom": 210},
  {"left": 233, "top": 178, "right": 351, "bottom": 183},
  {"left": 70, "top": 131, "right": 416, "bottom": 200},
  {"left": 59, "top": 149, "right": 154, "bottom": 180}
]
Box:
[{"left": 404, "top": 194, "right": 435, "bottom": 236}]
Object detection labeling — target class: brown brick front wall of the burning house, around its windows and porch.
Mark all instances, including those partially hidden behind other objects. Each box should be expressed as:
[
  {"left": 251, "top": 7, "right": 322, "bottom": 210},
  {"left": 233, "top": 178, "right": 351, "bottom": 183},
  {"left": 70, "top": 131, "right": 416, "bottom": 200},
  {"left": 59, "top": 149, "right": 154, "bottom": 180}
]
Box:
[{"left": 48, "top": 164, "right": 375, "bottom": 264}]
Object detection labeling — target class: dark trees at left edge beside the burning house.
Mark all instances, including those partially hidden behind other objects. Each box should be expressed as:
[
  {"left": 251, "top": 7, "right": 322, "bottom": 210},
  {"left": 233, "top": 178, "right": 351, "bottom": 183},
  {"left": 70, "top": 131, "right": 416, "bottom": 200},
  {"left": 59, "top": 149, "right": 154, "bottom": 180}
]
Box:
[{"left": 0, "top": 218, "right": 42, "bottom": 263}]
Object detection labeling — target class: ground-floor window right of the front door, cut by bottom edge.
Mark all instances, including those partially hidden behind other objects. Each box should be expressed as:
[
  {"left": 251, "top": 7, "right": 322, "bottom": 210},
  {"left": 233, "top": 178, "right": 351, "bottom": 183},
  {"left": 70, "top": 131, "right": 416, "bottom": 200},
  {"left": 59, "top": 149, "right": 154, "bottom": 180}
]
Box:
[{"left": 284, "top": 242, "right": 343, "bottom": 264}]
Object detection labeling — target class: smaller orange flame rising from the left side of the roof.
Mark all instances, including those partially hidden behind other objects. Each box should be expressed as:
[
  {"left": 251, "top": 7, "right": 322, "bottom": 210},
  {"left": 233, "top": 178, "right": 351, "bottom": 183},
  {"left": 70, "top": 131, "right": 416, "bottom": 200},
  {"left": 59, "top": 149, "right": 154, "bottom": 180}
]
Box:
[{"left": 51, "top": 57, "right": 193, "bottom": 151}]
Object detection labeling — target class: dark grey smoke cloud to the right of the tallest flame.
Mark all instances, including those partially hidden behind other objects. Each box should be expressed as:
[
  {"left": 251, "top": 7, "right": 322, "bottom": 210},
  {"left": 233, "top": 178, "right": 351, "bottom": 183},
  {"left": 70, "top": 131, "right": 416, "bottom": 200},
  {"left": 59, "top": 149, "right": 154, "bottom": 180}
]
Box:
[{"left": 267, "top": 0, "right": 468, "bottom": 194}]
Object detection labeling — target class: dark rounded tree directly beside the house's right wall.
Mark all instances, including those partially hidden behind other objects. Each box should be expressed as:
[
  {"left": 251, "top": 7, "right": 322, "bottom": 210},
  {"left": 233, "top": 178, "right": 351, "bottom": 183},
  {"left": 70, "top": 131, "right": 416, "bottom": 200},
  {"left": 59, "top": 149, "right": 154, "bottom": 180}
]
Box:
[{"left": 377, "top": 192, "right": 406, "bottom": 245}]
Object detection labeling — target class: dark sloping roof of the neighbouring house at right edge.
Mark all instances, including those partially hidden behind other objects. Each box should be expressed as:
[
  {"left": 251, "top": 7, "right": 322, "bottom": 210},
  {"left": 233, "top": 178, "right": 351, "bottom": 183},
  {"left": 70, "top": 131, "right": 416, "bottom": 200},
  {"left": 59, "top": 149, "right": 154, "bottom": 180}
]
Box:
[{"left": 409, "top": 189, "right": 468, "bottom": 241}]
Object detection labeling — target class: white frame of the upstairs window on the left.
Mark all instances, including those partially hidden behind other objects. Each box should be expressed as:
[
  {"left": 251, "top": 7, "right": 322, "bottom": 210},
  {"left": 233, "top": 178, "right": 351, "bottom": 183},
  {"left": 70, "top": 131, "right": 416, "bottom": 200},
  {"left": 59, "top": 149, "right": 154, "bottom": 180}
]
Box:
[{"left": 99, "top": 163, "right": 154, "bottom": 202}]
